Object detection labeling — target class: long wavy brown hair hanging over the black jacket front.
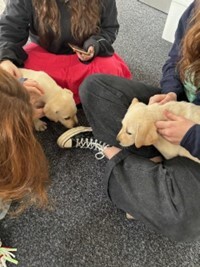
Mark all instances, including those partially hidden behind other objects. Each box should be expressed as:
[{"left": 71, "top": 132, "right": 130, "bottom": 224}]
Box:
[{"left": 32, "top": 0, "right": 101, "bottom": 45}]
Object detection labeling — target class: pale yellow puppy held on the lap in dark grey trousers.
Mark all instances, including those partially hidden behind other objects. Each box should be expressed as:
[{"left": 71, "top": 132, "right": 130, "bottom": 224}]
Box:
[{"left": 117, "top": 98, "right": 200, "bottom": 163}]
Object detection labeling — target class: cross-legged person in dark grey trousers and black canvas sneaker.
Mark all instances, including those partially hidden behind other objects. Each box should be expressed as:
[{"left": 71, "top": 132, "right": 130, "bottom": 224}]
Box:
[{"left": 58, "top": 0, "right": 200, "bottom": 241}]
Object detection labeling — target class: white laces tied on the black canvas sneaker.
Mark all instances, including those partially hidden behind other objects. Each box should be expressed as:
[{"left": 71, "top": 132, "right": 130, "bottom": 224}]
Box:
[{"left": 75, "top": 138, "right": 109, "bottom": 160}]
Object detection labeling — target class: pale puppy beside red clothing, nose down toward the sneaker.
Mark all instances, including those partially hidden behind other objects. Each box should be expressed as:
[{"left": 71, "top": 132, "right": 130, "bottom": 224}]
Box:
[{"left": 20, "top": 69, "right": 78, "bottom": 131}]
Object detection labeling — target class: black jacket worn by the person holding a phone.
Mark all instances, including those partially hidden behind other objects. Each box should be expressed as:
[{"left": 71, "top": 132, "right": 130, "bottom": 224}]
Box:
[{"left": 0, "top": 0, "right": 119, "bottom": 67}]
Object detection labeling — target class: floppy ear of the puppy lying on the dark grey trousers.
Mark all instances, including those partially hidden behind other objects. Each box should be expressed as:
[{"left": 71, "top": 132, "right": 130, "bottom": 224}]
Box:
[{"left": 135, "top": 123, "right": 158, "bottom": 148}]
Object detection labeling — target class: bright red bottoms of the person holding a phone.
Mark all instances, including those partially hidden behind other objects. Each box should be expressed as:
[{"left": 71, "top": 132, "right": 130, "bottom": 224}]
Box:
[{"left": 25, "top": 43, "right": 132, "bottom": 104}]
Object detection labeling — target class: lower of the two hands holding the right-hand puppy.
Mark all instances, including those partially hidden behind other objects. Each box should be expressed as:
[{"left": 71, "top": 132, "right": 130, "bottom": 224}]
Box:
[{"left": 155, "top": 110, "right": 195, "bottom": 145}]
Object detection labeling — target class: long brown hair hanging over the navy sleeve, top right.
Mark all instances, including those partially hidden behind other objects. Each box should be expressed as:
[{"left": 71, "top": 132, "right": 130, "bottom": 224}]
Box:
[{"left": 178, "top": 0, "right": 200, "bottom": 87}]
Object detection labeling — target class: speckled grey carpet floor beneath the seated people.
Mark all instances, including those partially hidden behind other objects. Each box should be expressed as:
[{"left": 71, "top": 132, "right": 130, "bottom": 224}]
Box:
[{"left": 0, "top": 0, "right": 200, "bottom": 267}]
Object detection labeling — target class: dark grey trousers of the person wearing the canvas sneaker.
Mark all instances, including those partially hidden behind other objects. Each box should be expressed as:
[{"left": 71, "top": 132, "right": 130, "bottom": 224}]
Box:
[{"left": 80, "top": 74, "right": 200, "bottom": 241}]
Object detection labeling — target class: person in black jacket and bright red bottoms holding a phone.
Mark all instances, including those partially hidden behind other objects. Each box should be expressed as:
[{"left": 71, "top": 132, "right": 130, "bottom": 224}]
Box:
[{"left": 0, "top": 0, "right": 131, "bottom": 104}]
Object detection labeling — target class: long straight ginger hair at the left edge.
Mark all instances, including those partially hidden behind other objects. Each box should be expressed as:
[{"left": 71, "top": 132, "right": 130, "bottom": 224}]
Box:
[{"left": 0, "top": 69, "right": 49, "bottom": 216}]
